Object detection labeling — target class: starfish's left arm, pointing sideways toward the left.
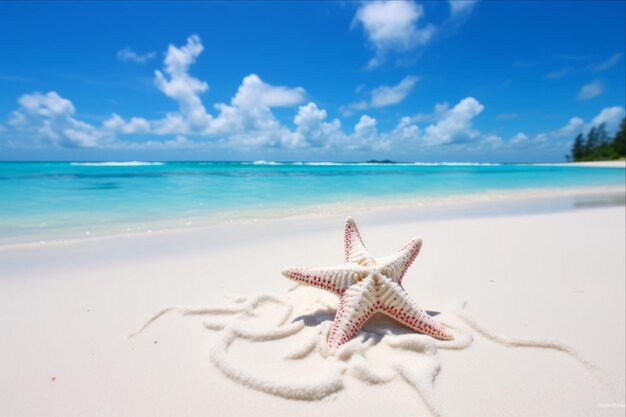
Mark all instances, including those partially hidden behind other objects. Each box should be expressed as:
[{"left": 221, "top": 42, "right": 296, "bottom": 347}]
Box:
[{"left": 282, "top": 265, "right": 363, "bottom": 296}]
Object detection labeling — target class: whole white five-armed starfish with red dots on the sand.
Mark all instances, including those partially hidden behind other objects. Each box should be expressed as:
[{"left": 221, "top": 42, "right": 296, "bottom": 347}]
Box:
[{"left": 282, "top": 217, "right": 453, "bottom": 352}]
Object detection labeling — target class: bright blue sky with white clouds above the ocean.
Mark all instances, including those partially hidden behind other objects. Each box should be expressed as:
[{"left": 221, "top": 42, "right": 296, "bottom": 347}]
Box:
[{"left": 0, "top": 1, "right": 626, "bottom": 161}]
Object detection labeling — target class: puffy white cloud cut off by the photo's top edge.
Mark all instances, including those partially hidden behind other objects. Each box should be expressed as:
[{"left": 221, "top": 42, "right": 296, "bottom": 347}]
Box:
[{"left": 353, "top": 0, "right": 435, "bottom": 68}]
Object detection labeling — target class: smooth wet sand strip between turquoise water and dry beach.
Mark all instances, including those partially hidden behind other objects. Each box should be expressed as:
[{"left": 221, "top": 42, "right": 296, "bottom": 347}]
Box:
[{"left": 0, "top": 186, "right": 626, "bottom": 252}]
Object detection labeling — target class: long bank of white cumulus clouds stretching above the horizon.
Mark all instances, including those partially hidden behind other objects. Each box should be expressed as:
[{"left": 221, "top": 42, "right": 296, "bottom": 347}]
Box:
[{"left": 3, "top": 36, "right": 624, "bottom": 158}]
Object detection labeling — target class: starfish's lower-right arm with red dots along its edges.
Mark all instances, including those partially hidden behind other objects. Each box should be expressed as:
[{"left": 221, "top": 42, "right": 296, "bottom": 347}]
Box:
[{"left": 378, "top": 283, "right": 453, "bottom": 340}]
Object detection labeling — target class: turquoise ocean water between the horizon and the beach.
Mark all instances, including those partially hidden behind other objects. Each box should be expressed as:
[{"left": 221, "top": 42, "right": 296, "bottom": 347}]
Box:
[{"left": 0, "top": 161, "right": 625, "bottom": 243}]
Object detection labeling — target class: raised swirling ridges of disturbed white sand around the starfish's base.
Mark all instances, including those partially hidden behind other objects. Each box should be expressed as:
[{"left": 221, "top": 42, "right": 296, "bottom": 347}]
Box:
[{"left": 131, "top": 286, "right": 592, "bottom": 416}]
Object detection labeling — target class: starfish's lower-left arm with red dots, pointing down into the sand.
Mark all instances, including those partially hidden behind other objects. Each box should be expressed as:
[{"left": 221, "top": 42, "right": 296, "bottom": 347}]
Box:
[{"left": 328, "top": 283, "right": 376, "bottom": 352}]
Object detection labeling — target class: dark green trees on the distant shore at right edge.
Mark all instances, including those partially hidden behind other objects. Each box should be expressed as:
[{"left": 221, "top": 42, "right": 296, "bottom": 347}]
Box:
[{"left": 567, "top": 117, "right": 626, "bottom": 162}]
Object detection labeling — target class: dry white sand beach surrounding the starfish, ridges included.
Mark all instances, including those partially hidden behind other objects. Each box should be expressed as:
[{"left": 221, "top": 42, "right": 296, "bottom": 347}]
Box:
[{"left": 0, "top": 206, "right": 626, "bottom": 416}]
